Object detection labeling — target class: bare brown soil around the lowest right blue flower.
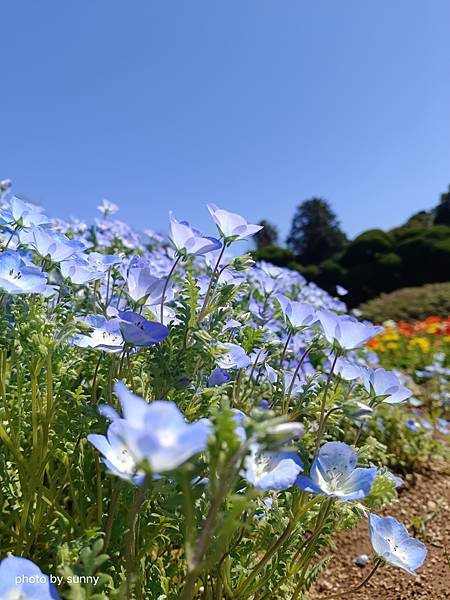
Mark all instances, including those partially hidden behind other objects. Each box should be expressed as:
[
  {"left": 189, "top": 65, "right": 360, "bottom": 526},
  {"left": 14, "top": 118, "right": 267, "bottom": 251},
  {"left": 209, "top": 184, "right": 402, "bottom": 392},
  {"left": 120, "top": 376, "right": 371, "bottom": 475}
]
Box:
[{"left": 311, "top": 465, "right": 450, "bottom": 600}]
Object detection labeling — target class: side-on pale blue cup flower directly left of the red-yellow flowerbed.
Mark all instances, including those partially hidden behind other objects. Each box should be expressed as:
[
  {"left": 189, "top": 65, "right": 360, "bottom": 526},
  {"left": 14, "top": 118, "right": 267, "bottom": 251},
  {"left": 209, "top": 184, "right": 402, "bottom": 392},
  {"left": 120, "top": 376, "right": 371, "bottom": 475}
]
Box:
[{"left": 317, "top": 310, "right": 383, "bottom": 350}]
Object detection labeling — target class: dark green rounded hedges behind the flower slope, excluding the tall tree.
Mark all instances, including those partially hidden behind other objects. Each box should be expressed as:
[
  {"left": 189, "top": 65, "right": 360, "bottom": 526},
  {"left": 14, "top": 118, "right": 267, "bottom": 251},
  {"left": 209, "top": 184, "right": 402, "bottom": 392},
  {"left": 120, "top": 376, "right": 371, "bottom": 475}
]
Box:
[{"left": 254, "top": 225, "right": 450, "bottom": 308}]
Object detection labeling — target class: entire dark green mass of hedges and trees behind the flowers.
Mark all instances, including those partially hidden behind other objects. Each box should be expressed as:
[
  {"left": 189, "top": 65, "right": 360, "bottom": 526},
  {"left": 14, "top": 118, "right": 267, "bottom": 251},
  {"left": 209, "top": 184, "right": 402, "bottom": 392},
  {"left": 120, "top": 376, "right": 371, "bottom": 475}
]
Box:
[{"left": 255, "top": 192, "right": 450, "bottom": 307}]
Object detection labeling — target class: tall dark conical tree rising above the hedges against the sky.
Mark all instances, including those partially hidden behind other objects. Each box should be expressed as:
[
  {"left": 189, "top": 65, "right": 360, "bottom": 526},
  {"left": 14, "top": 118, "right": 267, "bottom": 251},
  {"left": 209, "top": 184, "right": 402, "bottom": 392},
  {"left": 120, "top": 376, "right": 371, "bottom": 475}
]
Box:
[{"left": 287, "top": 198, "right": 347, "bottom": 265}]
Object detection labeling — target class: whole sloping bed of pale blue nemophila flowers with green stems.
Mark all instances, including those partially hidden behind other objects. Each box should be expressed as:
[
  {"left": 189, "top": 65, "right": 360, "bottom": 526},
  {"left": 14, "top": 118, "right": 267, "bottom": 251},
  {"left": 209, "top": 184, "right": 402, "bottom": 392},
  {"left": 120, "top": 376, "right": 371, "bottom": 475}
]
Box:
[{"left": 0, "top": 186, "right": 448, "bottom": 600}]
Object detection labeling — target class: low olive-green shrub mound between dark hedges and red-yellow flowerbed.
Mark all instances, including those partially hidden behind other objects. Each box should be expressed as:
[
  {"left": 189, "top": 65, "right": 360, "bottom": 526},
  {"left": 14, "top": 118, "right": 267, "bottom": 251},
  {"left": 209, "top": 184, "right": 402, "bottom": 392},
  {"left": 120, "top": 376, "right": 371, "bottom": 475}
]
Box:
[{"left": 359, "top": 282, "right": 450, "bottom": 323}]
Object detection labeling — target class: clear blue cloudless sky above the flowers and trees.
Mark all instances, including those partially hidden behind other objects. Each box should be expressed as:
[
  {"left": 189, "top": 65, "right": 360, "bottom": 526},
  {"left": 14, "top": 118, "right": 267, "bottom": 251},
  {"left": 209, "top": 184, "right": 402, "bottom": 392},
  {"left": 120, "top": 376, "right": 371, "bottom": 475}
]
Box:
[{"left": 0, "top": 0, "right": 450, "bottom": 241}]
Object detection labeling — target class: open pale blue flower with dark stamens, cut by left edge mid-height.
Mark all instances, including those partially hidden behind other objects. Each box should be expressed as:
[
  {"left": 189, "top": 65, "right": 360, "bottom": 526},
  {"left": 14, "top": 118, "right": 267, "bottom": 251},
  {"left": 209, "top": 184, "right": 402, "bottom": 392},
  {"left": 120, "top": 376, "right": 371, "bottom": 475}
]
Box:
[{"left": 0, "top": 250, "right": 47, "bottom": 295}]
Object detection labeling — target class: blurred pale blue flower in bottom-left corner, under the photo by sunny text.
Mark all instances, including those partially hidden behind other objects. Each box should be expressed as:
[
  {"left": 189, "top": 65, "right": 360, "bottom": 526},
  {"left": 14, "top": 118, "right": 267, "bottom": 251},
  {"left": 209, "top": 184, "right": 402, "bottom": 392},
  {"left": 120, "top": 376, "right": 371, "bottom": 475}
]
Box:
[{"left": 0, "top": 556, "right": 59, "bottom": 600}]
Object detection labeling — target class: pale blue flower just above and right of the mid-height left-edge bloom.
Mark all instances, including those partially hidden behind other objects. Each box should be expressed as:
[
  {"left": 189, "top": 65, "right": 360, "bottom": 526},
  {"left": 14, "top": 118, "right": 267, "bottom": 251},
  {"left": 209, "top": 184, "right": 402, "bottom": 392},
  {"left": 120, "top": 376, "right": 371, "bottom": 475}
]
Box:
[{"left": 20, "top": 226, "right": 84, "bottom": 262}]
